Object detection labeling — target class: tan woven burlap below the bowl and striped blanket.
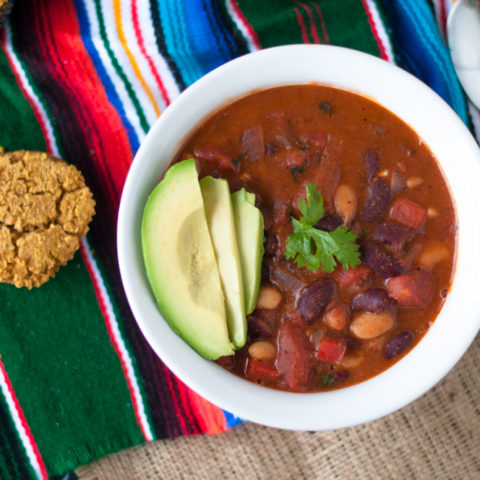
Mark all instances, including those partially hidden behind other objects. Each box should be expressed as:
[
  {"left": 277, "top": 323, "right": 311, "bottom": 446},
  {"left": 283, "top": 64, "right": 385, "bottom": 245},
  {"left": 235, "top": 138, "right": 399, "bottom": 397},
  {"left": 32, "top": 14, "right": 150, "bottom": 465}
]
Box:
[{"left": 76, "top": 336, "right": 480, "bottom": 480}]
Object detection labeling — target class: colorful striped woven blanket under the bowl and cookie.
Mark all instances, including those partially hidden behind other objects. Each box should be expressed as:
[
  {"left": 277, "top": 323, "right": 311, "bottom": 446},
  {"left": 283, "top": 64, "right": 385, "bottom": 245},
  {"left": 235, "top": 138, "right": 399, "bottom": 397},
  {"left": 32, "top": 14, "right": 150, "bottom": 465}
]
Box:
[{"left": 0, "top": 0, "right": 480, "bottom": 480}]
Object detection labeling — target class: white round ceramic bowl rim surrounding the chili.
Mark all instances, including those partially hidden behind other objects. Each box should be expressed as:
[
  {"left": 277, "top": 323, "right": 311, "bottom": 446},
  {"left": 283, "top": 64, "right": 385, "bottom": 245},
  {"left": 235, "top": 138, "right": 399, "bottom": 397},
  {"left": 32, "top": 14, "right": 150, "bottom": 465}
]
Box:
[{"left": 117, "top": 45, "right": 480, "bottom": 430}]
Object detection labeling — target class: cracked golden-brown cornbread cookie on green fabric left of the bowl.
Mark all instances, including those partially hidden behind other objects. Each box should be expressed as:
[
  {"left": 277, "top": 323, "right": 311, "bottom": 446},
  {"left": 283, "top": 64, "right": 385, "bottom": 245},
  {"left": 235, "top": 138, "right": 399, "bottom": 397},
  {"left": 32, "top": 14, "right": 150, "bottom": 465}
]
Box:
[{"left": 0, "top": 147, "right": 95, "bottom": 289}]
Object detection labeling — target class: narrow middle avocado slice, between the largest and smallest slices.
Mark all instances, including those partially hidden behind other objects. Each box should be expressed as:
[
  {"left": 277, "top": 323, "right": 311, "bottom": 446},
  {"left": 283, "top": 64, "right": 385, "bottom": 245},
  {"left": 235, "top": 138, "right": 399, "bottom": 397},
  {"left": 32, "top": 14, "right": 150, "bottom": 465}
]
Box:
[{"left": 200, "top": 177, "right": 247, "bottom": 348}]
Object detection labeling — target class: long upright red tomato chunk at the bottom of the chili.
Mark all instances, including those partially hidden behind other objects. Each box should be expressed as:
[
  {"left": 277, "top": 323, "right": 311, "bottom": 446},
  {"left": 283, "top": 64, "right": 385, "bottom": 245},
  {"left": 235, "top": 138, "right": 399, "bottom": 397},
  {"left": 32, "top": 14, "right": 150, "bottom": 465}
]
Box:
[{"left": 275, "top": 322, "right": 312, "bottom": 390}]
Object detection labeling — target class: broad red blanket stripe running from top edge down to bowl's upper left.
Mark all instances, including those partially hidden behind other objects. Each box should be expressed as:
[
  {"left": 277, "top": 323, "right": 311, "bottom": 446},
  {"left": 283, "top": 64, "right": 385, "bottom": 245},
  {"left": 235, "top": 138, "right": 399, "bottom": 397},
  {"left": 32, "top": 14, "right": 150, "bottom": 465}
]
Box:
[{"left": 36, "top": 1, "right": 132, "bottom": 204}]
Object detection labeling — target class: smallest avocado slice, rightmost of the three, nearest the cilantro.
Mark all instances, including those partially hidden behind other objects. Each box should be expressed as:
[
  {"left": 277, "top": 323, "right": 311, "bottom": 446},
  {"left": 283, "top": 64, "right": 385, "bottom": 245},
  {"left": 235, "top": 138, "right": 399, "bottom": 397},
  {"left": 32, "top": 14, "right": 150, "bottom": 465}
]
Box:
[{"left": 231, "top": 188, "right": 264, "bottom": 315}]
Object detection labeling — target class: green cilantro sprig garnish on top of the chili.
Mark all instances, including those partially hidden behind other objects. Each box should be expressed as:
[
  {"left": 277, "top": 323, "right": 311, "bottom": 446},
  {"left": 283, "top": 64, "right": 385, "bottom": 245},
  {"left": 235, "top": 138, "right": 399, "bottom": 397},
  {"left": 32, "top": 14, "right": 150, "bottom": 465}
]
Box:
[{"left": 285, "top": 182, "right": 360, "bottom": 273}]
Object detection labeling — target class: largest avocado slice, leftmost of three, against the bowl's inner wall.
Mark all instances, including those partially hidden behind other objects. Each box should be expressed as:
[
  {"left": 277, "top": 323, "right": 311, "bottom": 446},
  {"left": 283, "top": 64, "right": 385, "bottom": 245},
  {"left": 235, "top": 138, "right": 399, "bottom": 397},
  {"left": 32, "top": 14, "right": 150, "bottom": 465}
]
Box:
[{"left": 142, "top": 159, "right": 234, "bottom": 359}]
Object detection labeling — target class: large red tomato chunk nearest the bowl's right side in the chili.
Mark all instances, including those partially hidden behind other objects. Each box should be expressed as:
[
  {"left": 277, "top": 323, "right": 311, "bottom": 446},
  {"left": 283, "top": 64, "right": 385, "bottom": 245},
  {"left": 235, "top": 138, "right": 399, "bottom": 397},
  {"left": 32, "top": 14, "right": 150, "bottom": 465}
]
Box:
[{"left": 387, "top": 270, "right": 434, "bottom": 307}]
